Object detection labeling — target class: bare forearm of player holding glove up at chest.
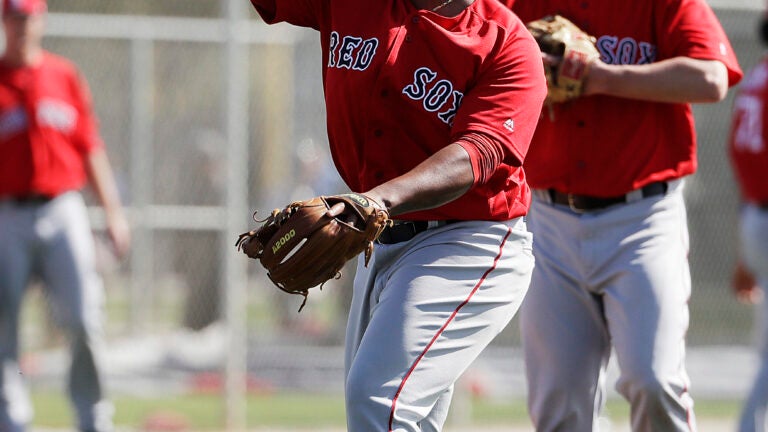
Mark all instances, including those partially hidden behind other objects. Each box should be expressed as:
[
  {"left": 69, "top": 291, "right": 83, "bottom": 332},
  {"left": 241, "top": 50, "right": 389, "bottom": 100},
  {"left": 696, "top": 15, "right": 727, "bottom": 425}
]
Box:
[{"left": 584, "top": 57, "right": 728, "bottom": 103}]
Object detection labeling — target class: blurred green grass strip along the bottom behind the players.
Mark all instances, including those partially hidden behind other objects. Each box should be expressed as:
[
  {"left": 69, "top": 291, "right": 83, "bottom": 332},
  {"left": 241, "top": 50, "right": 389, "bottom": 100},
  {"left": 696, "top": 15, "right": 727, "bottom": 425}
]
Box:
[{"left": 33, "top": 392, "right": 741, "bottom": 431}]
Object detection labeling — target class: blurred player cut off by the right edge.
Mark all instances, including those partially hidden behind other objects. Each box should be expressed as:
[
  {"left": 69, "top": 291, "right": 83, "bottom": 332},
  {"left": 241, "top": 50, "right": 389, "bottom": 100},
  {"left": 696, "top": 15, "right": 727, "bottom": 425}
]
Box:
[{"left": 729, "top": 8, "right": 768, "bottom": 432}]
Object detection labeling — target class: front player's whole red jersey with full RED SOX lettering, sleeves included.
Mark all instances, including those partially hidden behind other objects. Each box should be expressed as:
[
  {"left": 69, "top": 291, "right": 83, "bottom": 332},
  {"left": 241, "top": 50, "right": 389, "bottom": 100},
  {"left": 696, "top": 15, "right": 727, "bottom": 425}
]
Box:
[{"left": 251, "top": 0, "right": 546, "bottom": 220}]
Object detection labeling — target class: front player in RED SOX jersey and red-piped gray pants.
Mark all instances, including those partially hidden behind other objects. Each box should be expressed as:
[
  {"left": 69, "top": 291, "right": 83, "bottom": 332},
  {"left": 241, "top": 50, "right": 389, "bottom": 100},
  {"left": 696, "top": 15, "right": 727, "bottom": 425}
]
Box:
[{"left": 252, "top": 0, "right": 546, "bottom": 432}]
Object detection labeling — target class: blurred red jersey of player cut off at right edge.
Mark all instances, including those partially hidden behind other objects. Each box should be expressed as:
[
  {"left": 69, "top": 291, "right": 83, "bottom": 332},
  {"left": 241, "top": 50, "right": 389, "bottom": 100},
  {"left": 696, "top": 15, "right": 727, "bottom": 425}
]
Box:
[{"left": 729, "top": 57, "right": 768, "bottom": 204}]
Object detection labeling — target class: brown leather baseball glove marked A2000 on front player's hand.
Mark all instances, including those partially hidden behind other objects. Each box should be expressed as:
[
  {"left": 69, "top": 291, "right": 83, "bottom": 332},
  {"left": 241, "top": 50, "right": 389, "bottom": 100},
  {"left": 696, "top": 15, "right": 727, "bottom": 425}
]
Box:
[{"left": 235, "top": 193, "right": 391, "bottom": 311}]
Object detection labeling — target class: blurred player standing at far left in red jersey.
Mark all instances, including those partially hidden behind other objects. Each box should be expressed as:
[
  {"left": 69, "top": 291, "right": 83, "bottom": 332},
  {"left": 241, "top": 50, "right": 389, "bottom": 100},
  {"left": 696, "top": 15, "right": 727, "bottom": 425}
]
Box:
[{"left": 0, "top": 0, "right": 130, "bottom": 432}]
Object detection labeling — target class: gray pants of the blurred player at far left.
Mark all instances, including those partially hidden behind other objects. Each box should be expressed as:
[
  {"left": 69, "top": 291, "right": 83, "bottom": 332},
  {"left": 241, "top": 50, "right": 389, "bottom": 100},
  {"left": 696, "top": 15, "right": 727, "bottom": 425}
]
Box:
[{"left": 0, "top": 192, "right": 112, "bottom": 432}]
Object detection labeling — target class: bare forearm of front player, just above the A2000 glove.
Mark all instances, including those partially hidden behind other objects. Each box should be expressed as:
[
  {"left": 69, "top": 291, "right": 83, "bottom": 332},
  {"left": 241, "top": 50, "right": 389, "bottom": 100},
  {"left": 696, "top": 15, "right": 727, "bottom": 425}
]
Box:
[{"left": 365, "top": 144, "right": 474, "bottom": 216}]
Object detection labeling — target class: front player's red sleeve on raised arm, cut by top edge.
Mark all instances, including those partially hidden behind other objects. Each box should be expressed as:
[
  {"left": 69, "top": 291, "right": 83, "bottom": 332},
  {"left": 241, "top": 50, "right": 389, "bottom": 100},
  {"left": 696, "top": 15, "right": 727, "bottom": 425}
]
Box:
[{"left": 251, "top": 0, "right": 330, "bottom": 30}]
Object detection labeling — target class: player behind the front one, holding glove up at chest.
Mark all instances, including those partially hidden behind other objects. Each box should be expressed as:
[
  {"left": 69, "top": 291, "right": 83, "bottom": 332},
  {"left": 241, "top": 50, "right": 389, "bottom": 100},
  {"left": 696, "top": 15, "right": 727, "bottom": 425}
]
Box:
[{"left": 507, "top": 0, "right": 742, "bottom": 432}]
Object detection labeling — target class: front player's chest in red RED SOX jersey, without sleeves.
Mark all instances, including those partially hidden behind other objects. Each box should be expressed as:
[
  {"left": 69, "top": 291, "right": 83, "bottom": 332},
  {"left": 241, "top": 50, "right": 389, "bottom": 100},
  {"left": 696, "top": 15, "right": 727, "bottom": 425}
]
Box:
[{"left": 321, "top": 0, "right": 510, "bottom": 189}]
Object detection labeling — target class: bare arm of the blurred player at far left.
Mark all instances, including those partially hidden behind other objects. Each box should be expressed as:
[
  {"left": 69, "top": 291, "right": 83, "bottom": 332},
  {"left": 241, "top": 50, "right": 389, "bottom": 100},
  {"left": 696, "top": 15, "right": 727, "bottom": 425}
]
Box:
[{"left": 86, "top": 149, "right": 131, "bottom": 257}]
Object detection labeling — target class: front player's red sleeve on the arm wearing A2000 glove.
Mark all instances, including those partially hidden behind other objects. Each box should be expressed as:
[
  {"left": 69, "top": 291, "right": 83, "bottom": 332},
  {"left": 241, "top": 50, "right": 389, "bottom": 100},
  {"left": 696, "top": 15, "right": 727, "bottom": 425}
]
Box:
[{"left": 453, "top": 19, "right": 547, "bottom": 166}]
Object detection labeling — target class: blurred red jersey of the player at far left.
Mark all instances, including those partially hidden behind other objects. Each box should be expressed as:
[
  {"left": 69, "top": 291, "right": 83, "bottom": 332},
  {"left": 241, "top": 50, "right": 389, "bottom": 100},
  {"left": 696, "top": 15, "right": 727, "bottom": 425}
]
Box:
[{"left": 0, "top": 52, "right": 103, "bottom": 197}]
